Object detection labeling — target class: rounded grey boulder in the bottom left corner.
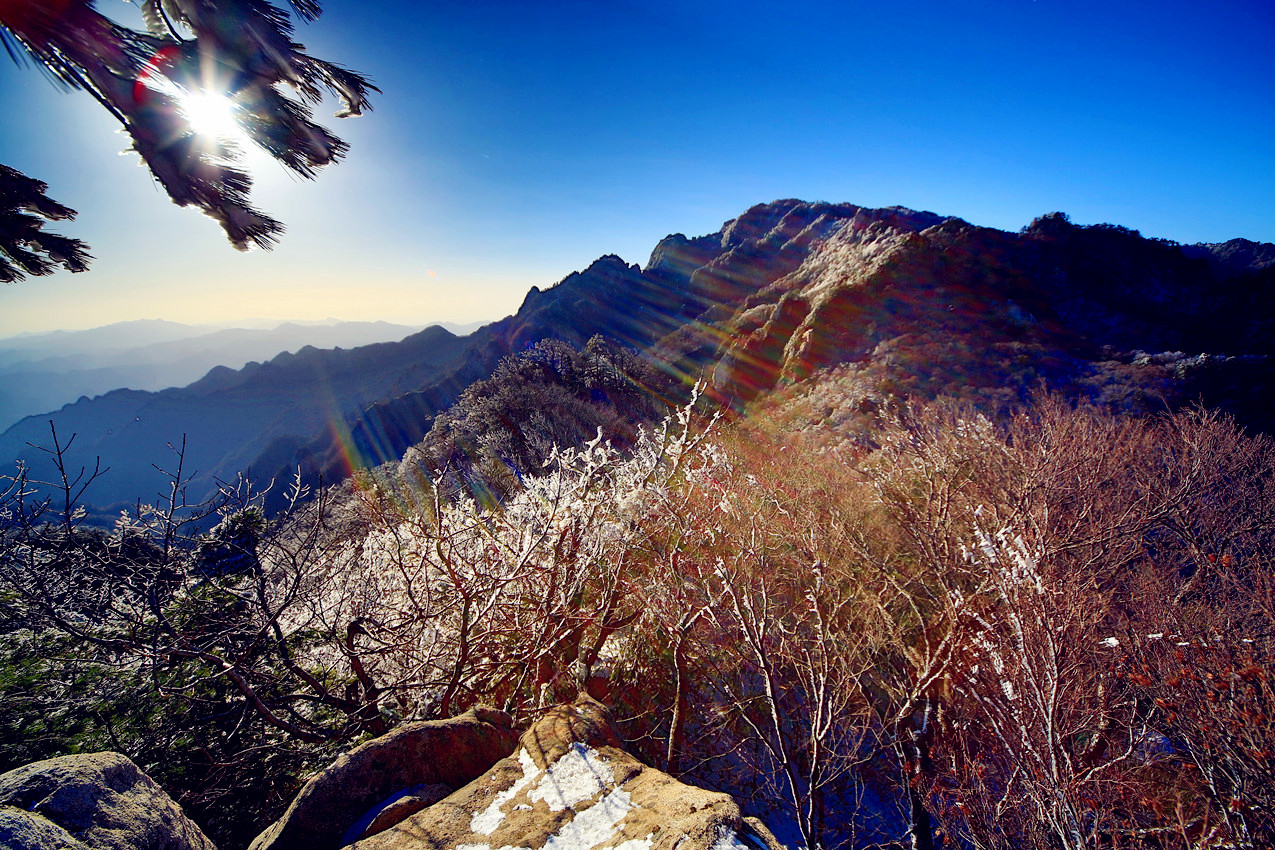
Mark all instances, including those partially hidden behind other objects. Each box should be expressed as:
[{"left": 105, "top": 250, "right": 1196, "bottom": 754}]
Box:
[{"left": 0, "top": 752, "right": 217, "bottom": 850}]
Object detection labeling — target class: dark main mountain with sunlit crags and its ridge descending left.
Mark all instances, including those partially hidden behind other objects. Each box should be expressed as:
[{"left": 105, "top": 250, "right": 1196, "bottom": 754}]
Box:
[{"left": 269, "top": 200, "right": 1275, "bottom": 504}]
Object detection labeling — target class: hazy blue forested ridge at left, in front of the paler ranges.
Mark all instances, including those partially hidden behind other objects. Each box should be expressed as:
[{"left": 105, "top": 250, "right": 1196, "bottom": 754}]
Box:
[{"left": 0, "top": 328, "right": 465, "bottom": 505}]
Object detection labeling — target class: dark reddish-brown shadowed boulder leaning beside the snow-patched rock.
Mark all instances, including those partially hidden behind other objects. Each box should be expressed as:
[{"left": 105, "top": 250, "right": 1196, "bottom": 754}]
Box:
[{"left": 251, "top": 707, "right": 518, "bottom": 850}]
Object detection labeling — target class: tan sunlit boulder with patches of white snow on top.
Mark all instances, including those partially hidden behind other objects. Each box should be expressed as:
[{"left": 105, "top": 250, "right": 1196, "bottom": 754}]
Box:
[{"left": 352, "top": 696, "right": 779, "bottom": 850}]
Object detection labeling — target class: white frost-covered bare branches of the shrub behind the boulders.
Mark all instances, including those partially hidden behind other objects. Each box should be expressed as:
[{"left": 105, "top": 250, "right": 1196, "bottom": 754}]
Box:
[{"left": 269, "top": 389, "right": 723, "bottom": 717}]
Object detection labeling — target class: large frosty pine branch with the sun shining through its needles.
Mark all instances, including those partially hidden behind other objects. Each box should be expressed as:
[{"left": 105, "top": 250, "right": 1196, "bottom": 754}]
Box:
[{"left": 0, "top": 0, "right": 379, "bottom": 250}]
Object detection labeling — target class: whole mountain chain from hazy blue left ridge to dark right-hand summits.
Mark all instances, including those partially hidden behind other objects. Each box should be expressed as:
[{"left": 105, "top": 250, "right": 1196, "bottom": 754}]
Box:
[{"left": 0, "top": 200, "right": 1275, "bottom": 514}]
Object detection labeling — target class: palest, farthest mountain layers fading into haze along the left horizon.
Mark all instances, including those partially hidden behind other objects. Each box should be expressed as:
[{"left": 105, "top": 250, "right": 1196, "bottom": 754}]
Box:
[{"left": 0, "top": 320, "right": 481, "bottom": 428}]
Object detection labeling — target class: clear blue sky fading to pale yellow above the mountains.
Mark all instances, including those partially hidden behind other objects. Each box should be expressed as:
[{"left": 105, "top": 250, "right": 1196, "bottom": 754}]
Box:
[{"left": 0, "top": 0, "right": 1275, "bottom": 336}]
